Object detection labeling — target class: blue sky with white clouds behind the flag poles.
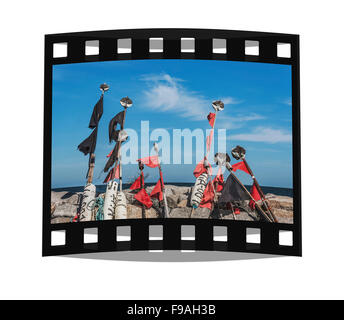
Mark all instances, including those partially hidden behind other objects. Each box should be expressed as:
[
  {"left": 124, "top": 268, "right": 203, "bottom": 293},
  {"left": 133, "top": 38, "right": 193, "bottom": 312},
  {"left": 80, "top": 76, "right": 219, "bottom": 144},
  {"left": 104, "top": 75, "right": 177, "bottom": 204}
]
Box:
[{"left": 52, "top": 60, "right": 292, "bottom": 188}]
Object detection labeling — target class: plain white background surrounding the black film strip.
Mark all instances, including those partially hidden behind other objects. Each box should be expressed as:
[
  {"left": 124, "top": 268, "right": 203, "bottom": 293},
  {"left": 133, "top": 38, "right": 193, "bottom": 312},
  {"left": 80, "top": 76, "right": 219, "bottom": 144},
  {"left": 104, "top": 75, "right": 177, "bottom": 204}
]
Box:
[{"left": 0, "top": 0, "right": 344, "bottom": 299}]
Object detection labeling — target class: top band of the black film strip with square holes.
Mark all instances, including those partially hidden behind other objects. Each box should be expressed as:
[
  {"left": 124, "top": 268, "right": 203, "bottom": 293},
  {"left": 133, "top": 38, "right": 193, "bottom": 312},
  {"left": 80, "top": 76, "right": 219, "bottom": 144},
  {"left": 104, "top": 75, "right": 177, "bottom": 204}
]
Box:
[{"left": 46, "top": 29, "right": 298, "bottom": 64}]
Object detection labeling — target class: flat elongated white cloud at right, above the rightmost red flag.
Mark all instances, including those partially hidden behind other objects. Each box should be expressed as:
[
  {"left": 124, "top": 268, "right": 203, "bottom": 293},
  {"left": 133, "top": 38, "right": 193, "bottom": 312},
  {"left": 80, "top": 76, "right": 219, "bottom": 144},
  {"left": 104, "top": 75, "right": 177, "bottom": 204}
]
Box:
[{"left": 229, "top": 127, "right": 292, "bottom": 143}]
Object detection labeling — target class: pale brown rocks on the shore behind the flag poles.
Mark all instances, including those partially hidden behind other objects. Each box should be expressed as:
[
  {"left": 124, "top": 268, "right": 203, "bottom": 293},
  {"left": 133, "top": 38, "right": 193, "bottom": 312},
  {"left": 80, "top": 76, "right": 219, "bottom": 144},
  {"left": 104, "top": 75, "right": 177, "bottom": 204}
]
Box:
[{"left": 51, "top": 185, "right": 293, "bottom": 223}]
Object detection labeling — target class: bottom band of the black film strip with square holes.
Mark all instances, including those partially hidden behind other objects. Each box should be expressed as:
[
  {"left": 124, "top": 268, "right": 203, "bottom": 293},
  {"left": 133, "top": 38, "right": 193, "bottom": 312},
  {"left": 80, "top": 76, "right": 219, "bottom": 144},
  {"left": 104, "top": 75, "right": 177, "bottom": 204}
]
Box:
[{"left": 43, "top": 219, "right": 300, "bottom": 255}]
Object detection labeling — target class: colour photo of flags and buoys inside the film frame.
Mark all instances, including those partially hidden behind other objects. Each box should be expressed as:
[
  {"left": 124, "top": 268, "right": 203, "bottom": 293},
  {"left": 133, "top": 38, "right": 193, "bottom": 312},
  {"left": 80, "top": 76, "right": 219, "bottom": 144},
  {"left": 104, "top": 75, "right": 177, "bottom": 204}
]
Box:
[{"left": 51, "top": 60, "right": 293, "bottom": 224}]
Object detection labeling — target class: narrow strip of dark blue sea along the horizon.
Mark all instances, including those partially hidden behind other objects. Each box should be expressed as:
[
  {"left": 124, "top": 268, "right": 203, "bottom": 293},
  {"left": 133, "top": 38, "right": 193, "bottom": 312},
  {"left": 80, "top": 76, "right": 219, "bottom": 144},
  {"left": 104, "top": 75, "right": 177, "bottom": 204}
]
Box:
[{"left": 51, "top": 182, "right": 293, "bottom": 197}]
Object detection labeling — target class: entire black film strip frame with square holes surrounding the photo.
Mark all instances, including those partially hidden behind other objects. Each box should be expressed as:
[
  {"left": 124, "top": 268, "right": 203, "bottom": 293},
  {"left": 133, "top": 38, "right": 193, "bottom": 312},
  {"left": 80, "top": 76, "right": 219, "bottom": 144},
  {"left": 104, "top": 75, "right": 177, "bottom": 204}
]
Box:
[{"left": 43, "top": 29, "right": 302, "bottom": 256}]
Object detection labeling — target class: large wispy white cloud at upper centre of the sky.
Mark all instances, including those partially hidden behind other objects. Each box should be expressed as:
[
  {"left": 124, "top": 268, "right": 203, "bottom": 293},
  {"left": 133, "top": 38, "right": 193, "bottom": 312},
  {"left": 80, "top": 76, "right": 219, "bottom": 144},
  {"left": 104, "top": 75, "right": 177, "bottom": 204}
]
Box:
[{"left": 141, "top": 74, "right": 237, "bottom": 121}]
